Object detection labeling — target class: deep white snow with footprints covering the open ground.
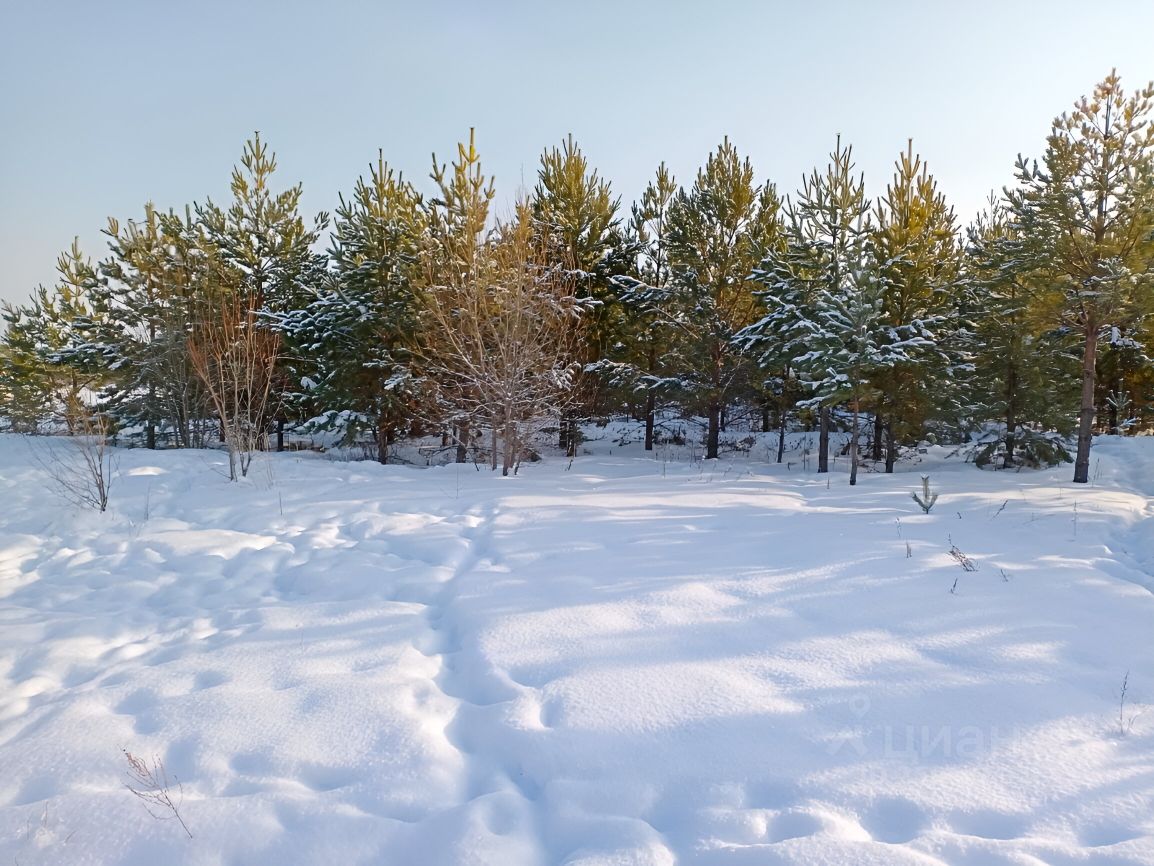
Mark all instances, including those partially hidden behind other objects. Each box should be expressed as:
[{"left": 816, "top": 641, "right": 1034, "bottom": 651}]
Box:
[{"left": 0, "top": 436, "right": 1154, "bottom": 866}]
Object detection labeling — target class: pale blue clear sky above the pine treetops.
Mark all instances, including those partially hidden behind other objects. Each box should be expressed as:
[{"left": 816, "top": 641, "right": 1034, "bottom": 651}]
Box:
[{"left": 0, "top": 0, "right": 1154, "bottom": 300}]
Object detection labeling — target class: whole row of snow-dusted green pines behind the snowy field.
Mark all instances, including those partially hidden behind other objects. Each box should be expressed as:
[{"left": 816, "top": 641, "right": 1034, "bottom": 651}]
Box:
[{"left": 0, "top": 73, "right": 1154, "bottom": 483}]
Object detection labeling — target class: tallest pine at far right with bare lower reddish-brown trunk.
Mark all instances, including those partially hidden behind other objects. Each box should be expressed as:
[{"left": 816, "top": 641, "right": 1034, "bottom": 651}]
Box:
[{"left": 1006, "top": 72, "right": 1154, "bottom": 484}]
